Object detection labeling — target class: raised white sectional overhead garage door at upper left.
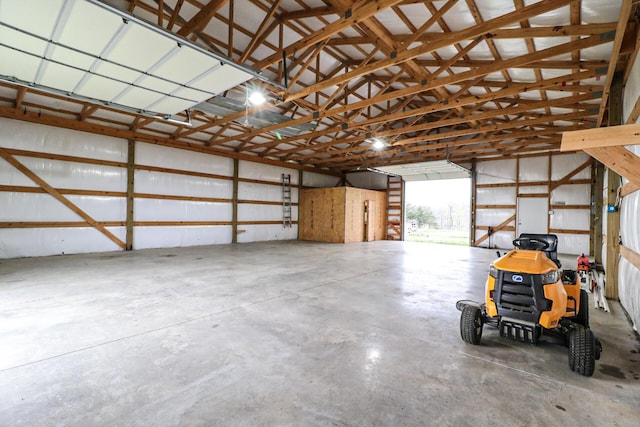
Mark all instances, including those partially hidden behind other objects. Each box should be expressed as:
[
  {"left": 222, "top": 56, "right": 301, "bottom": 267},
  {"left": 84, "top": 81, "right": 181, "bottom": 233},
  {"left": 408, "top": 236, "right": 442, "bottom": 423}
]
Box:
[{"left": 0, "top": 0, "right": 280, "bottom": 116}]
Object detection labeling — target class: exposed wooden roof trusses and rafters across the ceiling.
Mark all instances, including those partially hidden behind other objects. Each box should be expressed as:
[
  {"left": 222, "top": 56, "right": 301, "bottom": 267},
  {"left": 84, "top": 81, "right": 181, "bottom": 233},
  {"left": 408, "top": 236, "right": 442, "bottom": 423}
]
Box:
[{"left": 0, "top": 0, "right": 640, "bottom": 172}]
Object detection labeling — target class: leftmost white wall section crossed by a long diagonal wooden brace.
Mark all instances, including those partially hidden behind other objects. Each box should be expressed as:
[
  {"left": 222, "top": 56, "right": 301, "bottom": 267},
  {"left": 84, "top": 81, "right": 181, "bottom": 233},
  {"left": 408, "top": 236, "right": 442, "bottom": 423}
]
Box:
[{"left": 0, "top": 119, "right": 127, "bottom": 258}]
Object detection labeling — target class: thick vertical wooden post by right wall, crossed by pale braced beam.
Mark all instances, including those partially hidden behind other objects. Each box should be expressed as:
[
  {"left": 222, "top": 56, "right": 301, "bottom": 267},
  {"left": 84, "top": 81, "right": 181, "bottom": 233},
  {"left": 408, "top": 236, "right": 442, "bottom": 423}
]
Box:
[{"left": 604, "top": 71, "right": 623, "bottom": 300}]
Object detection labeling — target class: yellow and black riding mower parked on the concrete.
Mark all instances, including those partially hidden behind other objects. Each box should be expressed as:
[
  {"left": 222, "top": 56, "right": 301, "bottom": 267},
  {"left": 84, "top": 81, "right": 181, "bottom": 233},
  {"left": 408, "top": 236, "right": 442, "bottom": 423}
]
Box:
[{"left": 456, "top": 234, "right": 602, "bottom": 376}]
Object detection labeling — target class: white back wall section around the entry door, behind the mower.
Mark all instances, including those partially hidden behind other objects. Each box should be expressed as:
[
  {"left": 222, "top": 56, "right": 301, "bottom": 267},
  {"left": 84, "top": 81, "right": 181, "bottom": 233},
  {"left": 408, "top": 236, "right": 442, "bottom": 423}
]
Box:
[{"left": 474, "top": 153, "right": 591, "bottom": 254}]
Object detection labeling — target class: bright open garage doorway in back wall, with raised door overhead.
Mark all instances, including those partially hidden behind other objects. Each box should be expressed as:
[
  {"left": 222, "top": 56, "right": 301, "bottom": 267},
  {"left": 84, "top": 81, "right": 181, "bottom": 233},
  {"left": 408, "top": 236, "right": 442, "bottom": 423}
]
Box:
[{"left": 378, "top": 160, "right": 471, "bottom": 246}]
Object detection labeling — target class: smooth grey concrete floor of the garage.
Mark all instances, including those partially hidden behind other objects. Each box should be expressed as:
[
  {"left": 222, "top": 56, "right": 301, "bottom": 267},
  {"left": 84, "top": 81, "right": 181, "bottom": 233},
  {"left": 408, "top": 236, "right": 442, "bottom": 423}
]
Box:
[{"left": 0, "top": 241, "right": 640, "bottom": 426}]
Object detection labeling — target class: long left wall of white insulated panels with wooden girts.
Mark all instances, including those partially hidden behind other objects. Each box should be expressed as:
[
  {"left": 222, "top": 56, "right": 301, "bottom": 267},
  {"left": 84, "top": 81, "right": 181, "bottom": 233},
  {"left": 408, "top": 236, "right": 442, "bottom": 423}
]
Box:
[{"left": 0, "top": 119, "right": 322, "bottom": 258}]
